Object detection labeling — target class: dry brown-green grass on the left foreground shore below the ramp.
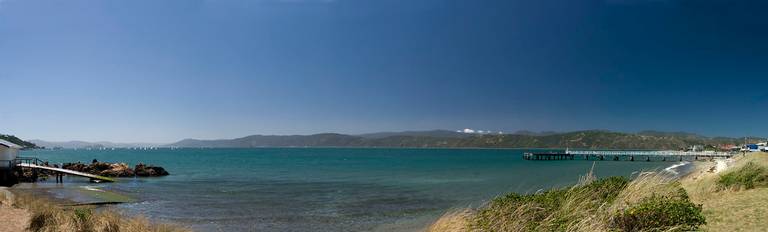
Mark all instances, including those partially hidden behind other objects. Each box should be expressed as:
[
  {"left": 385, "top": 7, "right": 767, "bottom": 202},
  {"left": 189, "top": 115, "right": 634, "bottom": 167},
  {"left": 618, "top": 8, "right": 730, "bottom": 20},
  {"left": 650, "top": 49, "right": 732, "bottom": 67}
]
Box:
[{"left": 14, "top": 195, "right": 189, "bottom": 232}]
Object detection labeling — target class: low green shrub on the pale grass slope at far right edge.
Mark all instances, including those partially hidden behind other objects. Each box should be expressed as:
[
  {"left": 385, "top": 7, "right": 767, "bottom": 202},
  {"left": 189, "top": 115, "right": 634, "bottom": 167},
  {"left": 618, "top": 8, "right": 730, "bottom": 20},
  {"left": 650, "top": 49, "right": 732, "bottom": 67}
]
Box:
[{"left": 717, "top": 162, "right": 768, "bottom": 189}]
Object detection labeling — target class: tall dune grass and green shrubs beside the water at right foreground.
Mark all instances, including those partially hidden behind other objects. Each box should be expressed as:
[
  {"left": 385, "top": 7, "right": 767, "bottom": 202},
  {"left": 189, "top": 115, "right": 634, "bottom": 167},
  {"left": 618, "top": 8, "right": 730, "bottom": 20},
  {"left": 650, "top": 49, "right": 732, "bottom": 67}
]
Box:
[{"left": 428, "top": 169, "right": 706, "bottom": 232}]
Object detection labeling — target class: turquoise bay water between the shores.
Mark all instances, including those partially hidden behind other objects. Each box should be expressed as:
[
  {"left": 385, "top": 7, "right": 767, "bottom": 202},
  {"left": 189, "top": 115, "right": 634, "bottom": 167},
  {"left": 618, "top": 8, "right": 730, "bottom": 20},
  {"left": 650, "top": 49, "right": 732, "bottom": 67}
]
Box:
[{"left": 23, "top": 148, "right": 674, "bottom": 231}]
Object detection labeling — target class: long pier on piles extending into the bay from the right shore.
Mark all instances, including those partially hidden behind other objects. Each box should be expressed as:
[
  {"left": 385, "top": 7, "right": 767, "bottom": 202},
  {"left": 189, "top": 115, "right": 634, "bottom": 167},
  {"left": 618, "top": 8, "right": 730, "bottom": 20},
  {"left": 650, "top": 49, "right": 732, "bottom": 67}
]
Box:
[{"left": 523, "top": 150, "right": 735, "bottom": 162}]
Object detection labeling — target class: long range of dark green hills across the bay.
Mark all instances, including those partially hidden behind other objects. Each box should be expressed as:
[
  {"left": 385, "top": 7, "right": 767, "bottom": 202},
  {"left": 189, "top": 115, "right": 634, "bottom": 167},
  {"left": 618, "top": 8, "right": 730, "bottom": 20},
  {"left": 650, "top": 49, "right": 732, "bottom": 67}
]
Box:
[{"left": 167, "top": 130, "right": 764, "bottom": 150}]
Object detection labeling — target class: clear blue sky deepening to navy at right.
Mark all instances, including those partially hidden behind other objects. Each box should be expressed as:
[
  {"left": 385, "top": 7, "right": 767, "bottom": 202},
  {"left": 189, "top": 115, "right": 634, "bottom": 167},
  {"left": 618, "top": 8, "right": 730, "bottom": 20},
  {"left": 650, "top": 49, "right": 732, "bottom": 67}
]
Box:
[{"left": 0, "top": 0, "right": 768, "bottom": 142}]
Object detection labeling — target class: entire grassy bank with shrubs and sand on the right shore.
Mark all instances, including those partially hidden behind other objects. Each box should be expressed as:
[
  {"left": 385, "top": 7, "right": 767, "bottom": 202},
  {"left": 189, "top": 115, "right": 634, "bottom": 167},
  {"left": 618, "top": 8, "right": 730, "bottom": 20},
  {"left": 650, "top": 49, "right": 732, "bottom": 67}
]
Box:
[{"left": 428, "top": 153, "right": 768, "bottom": 232}]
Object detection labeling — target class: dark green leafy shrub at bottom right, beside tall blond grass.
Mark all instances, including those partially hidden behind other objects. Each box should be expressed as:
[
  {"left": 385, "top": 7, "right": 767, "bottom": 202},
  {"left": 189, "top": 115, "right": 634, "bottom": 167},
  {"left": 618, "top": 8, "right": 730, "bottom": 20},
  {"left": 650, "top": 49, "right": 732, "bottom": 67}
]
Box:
[{"left": 613, "top": 188, "right": 706, "bottom": 231}]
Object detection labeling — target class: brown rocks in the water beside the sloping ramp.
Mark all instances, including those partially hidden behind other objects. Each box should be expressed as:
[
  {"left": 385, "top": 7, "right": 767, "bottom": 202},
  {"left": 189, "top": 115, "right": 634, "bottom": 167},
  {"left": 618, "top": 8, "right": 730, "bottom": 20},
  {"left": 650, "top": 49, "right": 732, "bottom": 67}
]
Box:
[{"left": 62, "top": 160, "right": 168, "bottom": 177}]
